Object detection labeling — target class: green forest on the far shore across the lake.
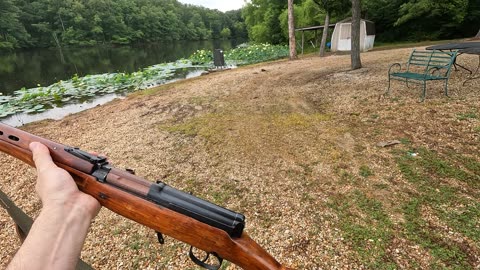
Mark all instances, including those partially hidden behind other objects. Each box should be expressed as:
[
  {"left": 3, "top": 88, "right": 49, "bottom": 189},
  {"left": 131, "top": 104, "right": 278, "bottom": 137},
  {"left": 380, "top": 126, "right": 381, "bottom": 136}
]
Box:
[{"left": 0, "top": 0, "right": 247, "bottom": 49}]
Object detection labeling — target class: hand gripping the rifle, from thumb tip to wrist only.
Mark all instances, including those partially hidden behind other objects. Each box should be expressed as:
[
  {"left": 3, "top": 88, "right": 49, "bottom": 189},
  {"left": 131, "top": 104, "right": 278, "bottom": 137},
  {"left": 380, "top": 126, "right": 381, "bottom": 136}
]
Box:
[{"left": 30, "top": 142, "right": 101, "bottom": 219}]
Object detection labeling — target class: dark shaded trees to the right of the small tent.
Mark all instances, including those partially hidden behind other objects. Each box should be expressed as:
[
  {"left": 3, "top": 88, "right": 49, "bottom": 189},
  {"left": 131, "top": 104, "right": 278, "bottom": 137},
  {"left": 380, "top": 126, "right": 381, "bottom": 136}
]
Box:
[{"left": 363, "top": 0, "right": 480, "bottom": 42}]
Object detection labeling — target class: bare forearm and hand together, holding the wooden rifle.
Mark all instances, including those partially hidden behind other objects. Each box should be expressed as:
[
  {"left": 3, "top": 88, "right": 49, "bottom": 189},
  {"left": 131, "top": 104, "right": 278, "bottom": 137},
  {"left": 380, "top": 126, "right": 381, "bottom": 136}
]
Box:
[{"left": 7, "top": 143, "right": 100, "bottom": 270}]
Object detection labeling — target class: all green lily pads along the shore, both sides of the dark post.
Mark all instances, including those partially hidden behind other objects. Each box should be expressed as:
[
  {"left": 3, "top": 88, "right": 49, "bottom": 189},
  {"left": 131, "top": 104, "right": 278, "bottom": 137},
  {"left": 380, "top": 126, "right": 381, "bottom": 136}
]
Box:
[{"left": 0, "top": 44, "right": 289, "bottom": 119}]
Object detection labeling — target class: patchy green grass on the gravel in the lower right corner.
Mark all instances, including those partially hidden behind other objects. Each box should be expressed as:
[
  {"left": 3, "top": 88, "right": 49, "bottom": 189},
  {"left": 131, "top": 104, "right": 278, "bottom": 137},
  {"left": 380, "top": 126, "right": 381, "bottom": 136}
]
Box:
[{"left": 329, "top": 148, "right": 480, "bottom": 269}]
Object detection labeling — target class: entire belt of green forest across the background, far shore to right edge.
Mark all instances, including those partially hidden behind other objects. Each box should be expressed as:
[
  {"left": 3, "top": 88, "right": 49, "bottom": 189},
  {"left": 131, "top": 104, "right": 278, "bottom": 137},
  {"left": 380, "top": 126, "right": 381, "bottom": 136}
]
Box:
[{"left": 0, "top": 0, "right": 480, "bottom": 50}]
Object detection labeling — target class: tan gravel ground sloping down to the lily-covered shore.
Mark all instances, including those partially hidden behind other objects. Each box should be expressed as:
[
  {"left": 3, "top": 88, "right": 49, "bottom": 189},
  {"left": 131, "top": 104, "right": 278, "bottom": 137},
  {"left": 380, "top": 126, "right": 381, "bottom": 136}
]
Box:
[{"left": 0, "top": 48, "right": 480, "bottom": 269}]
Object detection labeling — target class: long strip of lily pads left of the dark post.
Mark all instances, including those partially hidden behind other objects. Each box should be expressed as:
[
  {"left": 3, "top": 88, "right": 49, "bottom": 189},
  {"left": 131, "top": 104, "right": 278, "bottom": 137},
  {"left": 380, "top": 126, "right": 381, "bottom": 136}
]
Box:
[{"left": 0, "top": 60, "right": 206, "bottom": 118}]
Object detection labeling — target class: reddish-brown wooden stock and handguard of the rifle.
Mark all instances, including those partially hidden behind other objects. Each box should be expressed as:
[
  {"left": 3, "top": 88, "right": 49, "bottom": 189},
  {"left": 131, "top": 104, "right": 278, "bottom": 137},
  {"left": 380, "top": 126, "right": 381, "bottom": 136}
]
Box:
[{"left": 0, "top": 123, "right": 288, "bottom": 270}]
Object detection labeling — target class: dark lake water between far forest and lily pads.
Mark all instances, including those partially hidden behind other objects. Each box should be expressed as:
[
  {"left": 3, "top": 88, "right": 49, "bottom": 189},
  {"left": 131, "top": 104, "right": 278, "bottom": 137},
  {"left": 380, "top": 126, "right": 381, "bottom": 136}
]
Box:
[{"left": 0, "top": 40, "right": 245, "bottom": 95}]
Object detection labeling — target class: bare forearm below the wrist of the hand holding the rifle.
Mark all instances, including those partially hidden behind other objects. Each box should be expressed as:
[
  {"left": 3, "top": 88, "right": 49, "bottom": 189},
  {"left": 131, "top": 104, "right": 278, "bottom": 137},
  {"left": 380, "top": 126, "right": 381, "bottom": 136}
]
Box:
[{"left": 7, "top": 205, "right": 92, "bottom": 270}]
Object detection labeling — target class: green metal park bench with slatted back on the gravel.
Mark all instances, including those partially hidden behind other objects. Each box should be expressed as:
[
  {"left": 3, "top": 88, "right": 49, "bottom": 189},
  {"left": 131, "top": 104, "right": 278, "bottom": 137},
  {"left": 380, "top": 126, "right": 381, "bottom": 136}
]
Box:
[{"left": 385, "top": 49, "right": 457, "bottom": 101}]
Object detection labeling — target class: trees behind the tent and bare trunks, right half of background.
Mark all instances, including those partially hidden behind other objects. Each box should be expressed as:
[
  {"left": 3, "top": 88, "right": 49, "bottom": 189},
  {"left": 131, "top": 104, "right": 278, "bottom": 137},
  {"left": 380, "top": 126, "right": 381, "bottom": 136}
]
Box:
[{"left": 242, "top": 0, "right": 480, "bottom": 43}]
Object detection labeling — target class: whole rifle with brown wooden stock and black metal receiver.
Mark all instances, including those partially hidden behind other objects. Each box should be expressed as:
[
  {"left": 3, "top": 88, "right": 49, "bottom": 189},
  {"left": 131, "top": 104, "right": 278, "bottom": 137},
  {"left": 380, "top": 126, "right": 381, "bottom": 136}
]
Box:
[{"left": 0, "top": 123, "right": 288, "bottom": 270}]
